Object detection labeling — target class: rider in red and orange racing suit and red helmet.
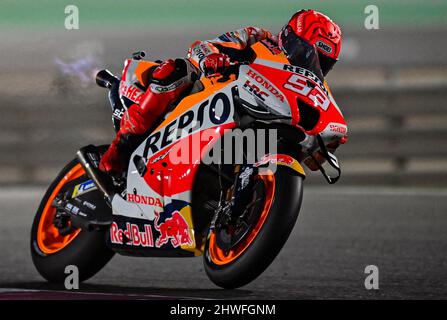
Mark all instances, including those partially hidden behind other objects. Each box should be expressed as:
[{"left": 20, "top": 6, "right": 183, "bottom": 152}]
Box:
[{"left": 99, "top": 10, "right": 342, "bottom": 173}]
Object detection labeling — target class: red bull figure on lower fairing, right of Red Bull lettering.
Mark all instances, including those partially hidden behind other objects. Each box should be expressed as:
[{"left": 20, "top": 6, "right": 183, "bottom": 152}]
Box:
[{"left": 154, "top": 211, "right": 193, "bottom": 248}]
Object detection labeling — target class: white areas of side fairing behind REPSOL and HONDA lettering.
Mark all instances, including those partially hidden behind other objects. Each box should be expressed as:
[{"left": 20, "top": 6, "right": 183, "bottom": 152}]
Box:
[{"left": 113, "top": 82, "right": 235, "bottom": 220}]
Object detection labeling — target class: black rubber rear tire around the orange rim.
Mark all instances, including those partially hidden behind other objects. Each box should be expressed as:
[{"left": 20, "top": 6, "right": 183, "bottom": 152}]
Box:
[{"left": 31, "top": 159, "right": 114, "bottom": 283}]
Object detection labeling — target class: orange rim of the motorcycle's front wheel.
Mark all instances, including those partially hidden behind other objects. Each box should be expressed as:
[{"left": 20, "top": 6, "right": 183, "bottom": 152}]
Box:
[{"left": 208, "top": 173, "right": 275, "bottom": 266}]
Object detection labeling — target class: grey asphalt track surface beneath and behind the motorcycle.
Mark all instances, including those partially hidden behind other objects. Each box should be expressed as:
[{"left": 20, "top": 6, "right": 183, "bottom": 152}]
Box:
[{"left": 0, "top": 186, "right": 447, "bottom": 299}]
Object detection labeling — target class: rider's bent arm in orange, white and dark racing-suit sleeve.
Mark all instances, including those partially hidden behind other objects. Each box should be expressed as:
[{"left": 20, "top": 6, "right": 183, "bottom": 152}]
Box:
[{"left": 188, "top": 27, "right": 272, "bottom": 67}]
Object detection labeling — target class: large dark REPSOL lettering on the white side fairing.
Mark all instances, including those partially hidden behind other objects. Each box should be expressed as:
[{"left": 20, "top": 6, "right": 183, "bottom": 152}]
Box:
[{"left": 143, "top": 92, "right": 233, "bottom": 158}]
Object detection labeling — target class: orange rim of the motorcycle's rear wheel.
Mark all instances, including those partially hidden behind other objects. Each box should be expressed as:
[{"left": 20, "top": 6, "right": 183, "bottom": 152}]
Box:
[{"left": 37, "top": 164, "right": 85, "bottom": 254}]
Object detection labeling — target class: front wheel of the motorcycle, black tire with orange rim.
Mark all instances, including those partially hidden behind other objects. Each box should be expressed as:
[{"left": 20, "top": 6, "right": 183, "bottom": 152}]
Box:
[{"left": 204, "top": 166, "right": 303, "bottom": 289}]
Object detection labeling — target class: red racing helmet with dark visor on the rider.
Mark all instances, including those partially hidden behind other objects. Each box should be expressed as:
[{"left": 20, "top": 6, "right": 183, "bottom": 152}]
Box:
[{"left": 279, "top": 9, "right": 342, "bottom": 76}]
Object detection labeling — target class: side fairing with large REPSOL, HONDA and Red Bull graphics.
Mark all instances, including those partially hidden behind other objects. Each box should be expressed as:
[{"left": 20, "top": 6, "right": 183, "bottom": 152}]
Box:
[{"left": 110, "top": 82, "right": 235, "bottom": 254}]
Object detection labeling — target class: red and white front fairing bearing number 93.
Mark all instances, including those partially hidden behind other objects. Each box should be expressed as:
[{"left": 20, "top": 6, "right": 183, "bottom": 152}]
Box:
[{"left": 239, "top": 59, "right": 347, "bottom": 145}]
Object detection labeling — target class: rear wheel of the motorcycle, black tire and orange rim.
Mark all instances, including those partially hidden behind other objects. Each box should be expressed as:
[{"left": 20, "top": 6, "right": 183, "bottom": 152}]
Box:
[{"left": 31, "top": 160, "right": 114, "bottom": 282}]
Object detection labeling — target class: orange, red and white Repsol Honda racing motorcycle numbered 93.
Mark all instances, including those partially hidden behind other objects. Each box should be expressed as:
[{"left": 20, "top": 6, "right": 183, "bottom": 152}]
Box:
[{"left": 31, "top": 40, "right": 347, "bottom": 288}]
